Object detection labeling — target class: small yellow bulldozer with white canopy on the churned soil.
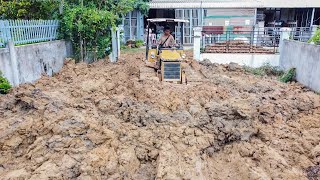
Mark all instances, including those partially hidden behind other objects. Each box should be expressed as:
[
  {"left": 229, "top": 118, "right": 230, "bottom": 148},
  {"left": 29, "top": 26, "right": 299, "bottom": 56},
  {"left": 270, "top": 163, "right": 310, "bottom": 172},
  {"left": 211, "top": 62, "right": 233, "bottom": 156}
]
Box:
[{"left": 140, "top": 18, "right": 189, "bottom": 84}]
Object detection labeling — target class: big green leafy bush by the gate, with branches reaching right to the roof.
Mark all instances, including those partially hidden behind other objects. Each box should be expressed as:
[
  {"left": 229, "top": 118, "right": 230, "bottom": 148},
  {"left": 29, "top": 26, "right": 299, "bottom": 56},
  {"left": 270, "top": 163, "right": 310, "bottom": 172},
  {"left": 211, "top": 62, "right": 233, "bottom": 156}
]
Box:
[{"left": 60, "top": 0, "right": 148, "bottom": 61}]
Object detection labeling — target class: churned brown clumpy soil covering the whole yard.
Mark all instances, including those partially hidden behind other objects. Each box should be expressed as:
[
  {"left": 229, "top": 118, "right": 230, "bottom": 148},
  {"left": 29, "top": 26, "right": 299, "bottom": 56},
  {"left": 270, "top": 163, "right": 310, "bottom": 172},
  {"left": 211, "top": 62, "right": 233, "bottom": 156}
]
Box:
[{"left": 0, "top": 53, "right": 320, "bottom": 180}]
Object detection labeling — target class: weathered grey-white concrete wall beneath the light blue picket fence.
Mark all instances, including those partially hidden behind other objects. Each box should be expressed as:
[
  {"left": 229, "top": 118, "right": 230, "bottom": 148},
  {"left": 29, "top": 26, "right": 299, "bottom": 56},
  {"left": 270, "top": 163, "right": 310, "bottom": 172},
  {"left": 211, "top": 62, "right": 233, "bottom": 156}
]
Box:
[{"left": 0, "top": 40, "right": 71, "bottom": 84}]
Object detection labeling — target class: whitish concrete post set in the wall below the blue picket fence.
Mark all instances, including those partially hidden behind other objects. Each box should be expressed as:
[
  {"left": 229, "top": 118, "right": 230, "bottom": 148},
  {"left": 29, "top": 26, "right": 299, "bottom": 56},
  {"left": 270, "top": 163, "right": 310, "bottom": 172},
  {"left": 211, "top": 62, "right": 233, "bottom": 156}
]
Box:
[{"left": 8, "top": 40, "right": 20, "bottom": 86}]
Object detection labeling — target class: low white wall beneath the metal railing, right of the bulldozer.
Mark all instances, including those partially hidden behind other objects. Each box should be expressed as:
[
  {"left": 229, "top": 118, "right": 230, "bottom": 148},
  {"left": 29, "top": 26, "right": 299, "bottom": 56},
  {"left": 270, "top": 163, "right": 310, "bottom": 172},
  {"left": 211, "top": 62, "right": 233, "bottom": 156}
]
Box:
[{"left": 201, "top": 53, "right": 280, "bottom": 67}]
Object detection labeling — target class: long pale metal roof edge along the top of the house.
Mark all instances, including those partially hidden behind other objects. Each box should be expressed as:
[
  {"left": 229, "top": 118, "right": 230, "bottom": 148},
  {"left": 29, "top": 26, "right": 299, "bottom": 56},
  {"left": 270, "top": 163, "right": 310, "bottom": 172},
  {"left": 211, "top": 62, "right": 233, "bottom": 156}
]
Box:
[{"left": 150, "top": 0, "right": 320, "bottom": 9}]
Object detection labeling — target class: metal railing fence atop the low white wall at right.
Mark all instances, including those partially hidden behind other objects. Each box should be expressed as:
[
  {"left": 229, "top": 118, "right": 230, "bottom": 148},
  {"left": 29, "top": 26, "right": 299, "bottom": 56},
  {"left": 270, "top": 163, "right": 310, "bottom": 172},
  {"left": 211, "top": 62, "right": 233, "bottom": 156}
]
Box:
[{"left": 202, "top": 27, "right": 312, "bottom": 53}]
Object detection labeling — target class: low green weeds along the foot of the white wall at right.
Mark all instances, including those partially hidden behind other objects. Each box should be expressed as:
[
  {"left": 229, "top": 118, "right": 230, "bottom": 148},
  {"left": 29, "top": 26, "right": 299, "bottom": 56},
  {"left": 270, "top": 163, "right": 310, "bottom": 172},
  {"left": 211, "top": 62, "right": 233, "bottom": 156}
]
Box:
[{"left": 244, "top": 63, "right": 283, "bottom": 76}]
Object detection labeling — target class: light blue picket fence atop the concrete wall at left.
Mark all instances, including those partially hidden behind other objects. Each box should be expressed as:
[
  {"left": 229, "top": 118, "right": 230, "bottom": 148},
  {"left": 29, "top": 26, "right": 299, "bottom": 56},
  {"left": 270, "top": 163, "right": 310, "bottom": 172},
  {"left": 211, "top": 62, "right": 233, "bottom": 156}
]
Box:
[{"left": 0, "top": 20, "right": 59, "bottom": 47}]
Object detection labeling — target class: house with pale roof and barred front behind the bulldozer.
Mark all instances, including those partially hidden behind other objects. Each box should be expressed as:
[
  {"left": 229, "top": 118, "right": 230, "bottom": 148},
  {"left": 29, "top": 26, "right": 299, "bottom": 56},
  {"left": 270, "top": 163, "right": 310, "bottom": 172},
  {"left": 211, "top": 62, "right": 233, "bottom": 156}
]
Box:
[{"left": 123, "top": 0, "right": 320, "bottom": 44}]
